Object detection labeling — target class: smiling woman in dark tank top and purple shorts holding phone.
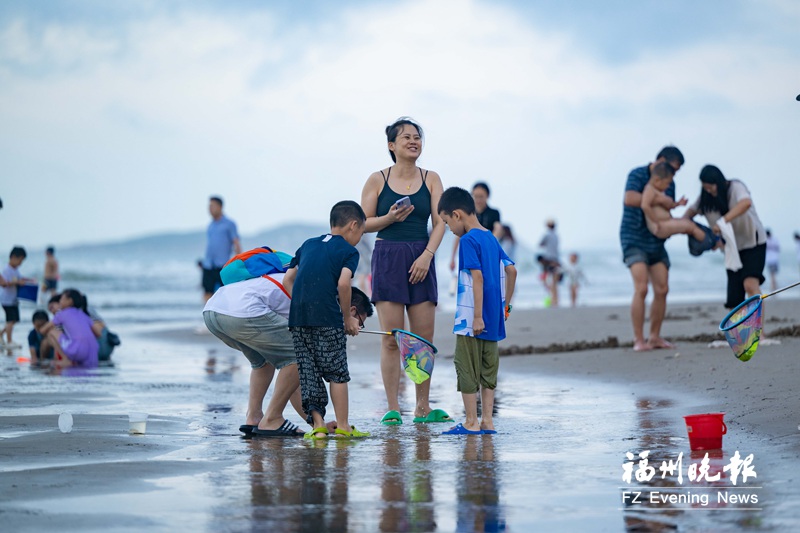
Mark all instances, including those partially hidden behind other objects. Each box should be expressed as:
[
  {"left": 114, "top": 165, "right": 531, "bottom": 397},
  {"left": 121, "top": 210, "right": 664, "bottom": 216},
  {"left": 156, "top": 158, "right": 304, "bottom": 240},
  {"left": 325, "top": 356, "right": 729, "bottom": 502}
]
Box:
[{"left": 361, "top": 117, "right": 452, "bottom": 425}]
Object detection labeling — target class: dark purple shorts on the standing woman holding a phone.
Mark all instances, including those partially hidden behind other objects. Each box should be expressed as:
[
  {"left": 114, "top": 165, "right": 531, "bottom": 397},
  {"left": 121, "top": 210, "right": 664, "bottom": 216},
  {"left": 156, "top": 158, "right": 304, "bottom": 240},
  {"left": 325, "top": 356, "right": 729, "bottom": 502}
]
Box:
[{"left": 372, "top": 239, "right": 439, "bottom": 305}]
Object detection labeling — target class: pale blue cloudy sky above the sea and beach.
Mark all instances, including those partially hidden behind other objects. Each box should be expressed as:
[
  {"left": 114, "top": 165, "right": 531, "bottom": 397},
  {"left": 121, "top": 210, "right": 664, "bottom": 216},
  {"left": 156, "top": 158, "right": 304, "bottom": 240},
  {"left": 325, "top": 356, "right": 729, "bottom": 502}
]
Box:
[{"left": 0, "top": 0, "right": 800, "bottom": 253}]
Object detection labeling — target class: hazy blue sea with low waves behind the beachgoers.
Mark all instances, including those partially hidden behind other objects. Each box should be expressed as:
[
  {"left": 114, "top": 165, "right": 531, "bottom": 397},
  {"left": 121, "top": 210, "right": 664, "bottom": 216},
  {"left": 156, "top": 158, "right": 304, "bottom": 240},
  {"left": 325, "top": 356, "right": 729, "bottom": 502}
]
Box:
[{"left": 14, "top": 233, "right": 798, "bottom": 326}]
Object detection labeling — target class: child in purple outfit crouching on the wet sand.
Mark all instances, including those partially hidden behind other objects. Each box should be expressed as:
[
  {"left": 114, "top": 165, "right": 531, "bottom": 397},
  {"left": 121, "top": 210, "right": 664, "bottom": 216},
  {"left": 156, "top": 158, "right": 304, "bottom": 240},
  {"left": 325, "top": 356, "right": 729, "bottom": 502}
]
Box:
[{"left": 39, "top": 289, "right": 99, "bottom": 368}]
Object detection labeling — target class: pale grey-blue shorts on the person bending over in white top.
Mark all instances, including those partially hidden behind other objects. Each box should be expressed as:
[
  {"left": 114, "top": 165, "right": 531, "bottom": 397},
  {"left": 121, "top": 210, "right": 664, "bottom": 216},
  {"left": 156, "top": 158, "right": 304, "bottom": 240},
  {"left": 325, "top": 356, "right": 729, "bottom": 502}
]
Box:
[{"left": 203, "top": 311, "right": 297, "bottom": 370}]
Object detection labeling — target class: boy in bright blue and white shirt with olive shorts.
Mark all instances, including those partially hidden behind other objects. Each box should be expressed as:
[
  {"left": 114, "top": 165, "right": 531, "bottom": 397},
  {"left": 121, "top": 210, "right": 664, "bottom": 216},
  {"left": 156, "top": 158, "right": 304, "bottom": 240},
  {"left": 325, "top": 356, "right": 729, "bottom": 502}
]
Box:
[{"left": 438, "top": 187, "right": 517, "bottom": 435}]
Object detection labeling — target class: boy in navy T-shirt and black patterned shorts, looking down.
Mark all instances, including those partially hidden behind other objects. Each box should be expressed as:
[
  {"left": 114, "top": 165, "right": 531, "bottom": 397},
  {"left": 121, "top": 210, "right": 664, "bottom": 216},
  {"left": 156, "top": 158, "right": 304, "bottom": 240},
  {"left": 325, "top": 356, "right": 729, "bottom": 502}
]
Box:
[{"left": 283, "top": 200, "right": 372, "bottom": 438}]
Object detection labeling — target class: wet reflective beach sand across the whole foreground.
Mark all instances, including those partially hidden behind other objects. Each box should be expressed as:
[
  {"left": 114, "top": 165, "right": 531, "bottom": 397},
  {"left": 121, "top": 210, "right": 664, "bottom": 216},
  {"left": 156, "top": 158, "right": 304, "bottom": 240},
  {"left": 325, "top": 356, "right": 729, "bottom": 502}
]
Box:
[{"left": 0, "top": 299, "right": 800, "bottom": 531}]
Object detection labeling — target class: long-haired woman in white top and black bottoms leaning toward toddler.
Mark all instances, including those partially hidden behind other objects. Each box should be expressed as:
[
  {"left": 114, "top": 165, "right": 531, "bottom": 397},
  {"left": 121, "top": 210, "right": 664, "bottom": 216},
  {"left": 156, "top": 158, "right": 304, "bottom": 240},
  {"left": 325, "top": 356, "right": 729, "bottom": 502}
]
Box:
[{"left": 683, "top": 165, "right": 767, "bottom": 309}]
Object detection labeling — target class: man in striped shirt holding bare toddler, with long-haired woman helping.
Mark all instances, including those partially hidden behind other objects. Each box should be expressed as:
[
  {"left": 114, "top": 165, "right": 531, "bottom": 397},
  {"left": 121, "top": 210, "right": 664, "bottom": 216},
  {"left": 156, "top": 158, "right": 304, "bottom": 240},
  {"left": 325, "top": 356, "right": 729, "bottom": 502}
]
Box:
[{"left": 620, "top": 146, "right": 778, "bottom": 351}]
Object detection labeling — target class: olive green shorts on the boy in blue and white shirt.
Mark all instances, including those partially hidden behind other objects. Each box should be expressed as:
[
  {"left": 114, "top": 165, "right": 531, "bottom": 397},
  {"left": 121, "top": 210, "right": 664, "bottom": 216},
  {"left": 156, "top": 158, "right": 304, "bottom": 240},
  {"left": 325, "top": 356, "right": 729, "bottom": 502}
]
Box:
[{"left": 454, "top": 335, "right": 500, "bottom": 394}]
